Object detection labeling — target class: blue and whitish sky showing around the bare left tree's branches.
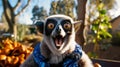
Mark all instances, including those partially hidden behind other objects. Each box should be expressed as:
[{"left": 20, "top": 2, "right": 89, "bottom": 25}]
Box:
[{"left": 0, "top": 0, "right": 53, "bottom": 24}]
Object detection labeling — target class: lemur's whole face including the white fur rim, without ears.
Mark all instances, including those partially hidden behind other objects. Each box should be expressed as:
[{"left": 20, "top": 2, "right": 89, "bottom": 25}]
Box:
[{"left": 44, "top": 15, "right": 75, "bottom": 53}]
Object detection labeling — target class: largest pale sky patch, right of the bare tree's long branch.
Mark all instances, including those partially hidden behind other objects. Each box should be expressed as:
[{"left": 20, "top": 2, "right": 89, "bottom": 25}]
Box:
[{"left": 19, "top": 0, "right": 52, "bottom": 24}]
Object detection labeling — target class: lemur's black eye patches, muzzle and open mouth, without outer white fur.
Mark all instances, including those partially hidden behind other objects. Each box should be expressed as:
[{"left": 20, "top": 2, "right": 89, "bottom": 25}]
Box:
[{"left": 45, "top": 17, "right": 72, "bottom": 49}]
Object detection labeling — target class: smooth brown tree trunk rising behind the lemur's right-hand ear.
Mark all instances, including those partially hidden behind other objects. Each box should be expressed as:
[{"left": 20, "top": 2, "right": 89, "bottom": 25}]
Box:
[{"left": 76, "top": 0, "right": 87, "bottom": 46}]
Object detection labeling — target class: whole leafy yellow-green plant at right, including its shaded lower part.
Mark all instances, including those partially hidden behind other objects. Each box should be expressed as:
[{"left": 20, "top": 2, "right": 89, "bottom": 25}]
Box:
[{"left": 87, "top": 1, "right": 112, "bottom": 53}]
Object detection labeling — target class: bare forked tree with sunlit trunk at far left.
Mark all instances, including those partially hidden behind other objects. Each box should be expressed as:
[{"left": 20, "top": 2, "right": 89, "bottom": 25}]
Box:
[{"left": 2, "top": 0, "right": 31, "bottom": 40}]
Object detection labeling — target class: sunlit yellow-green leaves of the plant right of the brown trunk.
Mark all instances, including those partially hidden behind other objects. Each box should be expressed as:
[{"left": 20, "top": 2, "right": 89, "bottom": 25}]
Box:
[{"left": 91, "top": 3, "right": 112, "bottom": 48}]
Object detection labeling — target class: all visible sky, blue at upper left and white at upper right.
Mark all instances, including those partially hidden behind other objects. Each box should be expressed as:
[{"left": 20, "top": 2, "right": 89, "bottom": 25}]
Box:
[{"left": 0, "top": 0, "right": 120, "bottom": 24}]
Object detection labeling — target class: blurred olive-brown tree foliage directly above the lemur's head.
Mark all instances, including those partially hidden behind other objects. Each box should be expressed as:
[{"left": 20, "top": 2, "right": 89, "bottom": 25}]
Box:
[{"left": 49, "top": 0, "right": 75, "bottom": 18}]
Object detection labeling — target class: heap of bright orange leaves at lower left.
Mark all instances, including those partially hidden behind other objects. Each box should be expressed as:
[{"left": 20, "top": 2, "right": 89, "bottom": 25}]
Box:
[{"left": 0, "top": 39, "right": 33, "bottom": 67}]
